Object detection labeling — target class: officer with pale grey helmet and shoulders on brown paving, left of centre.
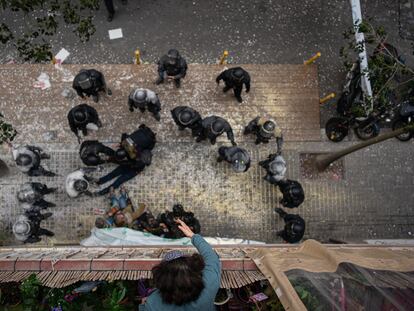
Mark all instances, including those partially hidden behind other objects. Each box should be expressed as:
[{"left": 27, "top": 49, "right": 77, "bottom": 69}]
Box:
[{"left": 128, "top": 88, "right": 161, "bottom": 121}]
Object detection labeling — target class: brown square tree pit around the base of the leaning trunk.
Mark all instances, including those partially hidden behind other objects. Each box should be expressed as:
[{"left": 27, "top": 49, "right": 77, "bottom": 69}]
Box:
[{"left": 299, "top": 153, "right": 344, "bottom": 181}]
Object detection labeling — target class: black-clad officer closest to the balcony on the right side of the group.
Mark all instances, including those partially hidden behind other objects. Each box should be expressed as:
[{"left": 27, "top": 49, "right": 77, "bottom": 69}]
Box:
[{"left": 275, "top": 208, "right": 305, "bottom": 243}]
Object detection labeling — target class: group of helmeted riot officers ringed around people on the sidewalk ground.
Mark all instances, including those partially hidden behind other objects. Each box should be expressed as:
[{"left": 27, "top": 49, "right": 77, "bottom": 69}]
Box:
[{"left": 13, "top": 49, "right": 305, "bottom": 243}]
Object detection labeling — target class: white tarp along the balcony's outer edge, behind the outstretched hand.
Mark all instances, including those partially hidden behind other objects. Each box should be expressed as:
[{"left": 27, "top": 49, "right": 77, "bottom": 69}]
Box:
[{"left": 80, "top": 228, "right": 265, "bottom": 246}]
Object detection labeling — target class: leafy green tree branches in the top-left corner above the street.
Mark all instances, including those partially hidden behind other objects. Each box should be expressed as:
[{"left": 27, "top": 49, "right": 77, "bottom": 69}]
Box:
[{"left": 0, "top": 0, "right": 100, "bottom": 62}]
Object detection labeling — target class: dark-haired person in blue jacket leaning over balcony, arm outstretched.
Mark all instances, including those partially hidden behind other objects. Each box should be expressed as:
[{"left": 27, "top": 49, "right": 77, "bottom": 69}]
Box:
[{"left": 139, "top": 220, "right": 221, "bottom": 311}]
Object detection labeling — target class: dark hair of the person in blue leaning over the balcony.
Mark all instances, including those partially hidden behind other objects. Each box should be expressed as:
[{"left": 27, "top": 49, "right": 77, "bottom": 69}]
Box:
[{"left": 152, "top": 254, "right": 204, "bottom": 306}]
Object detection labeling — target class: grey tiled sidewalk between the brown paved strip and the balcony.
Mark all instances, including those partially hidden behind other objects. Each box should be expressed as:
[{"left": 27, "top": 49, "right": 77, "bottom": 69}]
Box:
[{"left": 0, "top": 140, "right": 414, "bottom": 244}]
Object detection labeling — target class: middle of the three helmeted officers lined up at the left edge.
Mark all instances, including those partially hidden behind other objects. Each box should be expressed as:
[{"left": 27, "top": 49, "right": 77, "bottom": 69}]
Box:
[{"left": 16, "top": 182, "right": 57, "bottom": 209}]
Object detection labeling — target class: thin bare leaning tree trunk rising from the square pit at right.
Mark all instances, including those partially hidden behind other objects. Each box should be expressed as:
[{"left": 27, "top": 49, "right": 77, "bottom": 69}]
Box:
[{"left": 315, "top": 127, "right": 411, "bottom": 171}]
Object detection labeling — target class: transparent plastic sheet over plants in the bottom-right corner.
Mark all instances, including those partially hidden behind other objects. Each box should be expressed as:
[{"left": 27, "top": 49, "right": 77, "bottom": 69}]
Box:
[{"left": 286, "top": 263, "right": 414, "bottom": 311}]
